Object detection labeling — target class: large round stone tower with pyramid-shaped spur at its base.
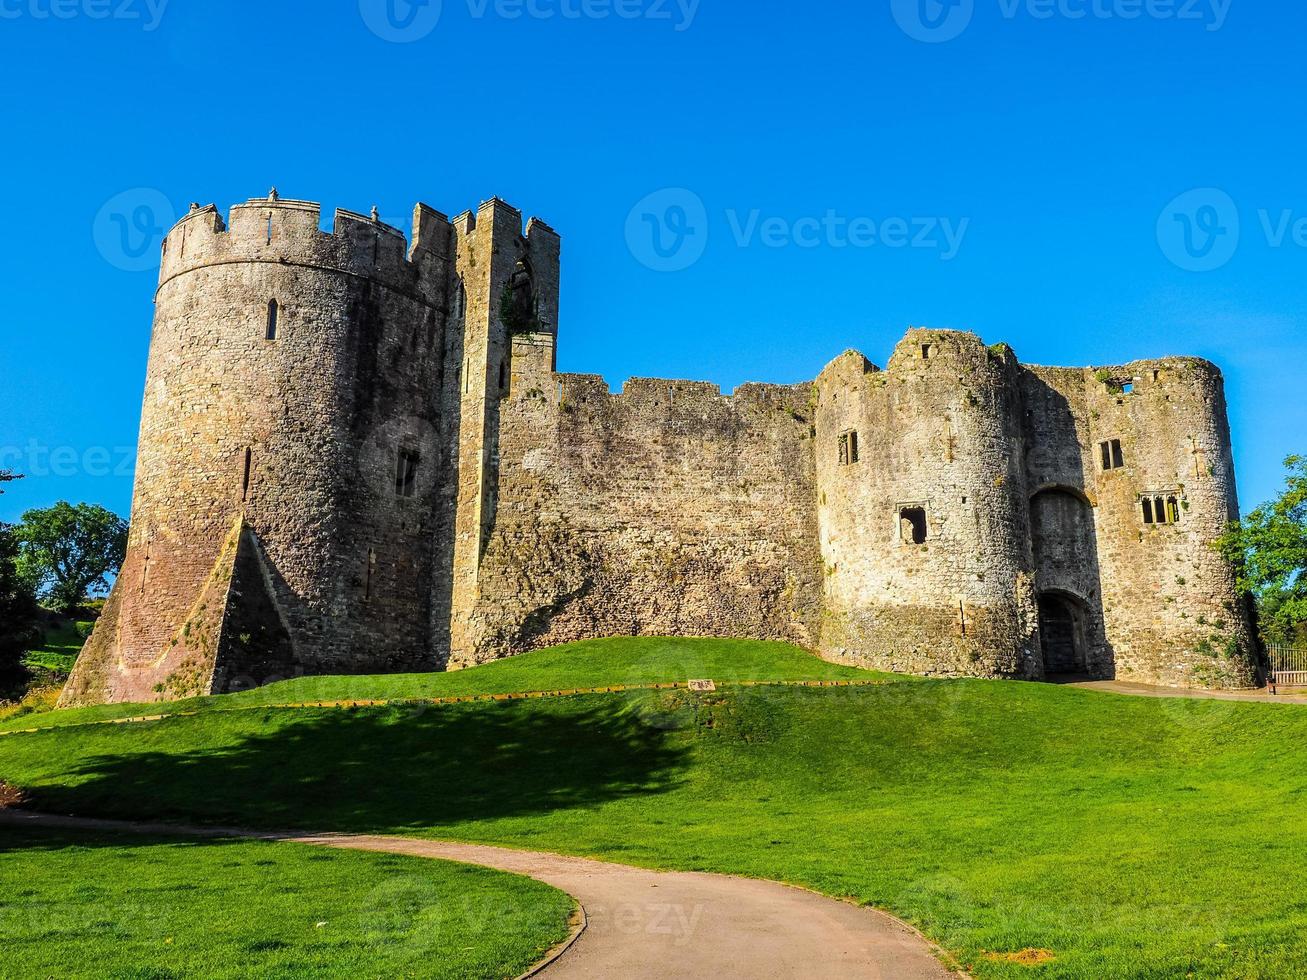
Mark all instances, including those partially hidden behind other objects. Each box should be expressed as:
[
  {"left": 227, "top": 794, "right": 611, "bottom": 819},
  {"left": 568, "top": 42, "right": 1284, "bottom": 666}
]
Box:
[{"left": 63, "top": 192, "right": 454, "bottom": 704}]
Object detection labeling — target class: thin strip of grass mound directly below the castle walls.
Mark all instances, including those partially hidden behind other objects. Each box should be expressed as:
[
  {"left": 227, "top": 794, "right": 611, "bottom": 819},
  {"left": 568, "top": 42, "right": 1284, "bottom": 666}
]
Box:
[{"left": 0, "top": 636, "right": 888, "bottom": 732}]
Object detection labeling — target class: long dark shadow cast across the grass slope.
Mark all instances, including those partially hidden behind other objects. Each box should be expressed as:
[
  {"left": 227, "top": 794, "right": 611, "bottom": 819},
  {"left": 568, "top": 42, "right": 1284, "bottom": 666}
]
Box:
[{"left": 17, "top": 699, "right": 689, "bottom": 832}]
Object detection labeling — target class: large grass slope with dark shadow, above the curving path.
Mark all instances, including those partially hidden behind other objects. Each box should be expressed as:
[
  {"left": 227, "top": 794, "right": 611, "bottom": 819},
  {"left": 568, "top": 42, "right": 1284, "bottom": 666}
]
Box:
[{"left": 0, "top": 642, "right": 1307, "bottom": 980}]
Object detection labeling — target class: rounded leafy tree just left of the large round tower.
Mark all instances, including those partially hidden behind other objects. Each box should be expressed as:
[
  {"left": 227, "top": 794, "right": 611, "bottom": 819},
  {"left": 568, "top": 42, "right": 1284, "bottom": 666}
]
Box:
[{"left": 18, "top": 500, "right": 127, "bottom": 614}]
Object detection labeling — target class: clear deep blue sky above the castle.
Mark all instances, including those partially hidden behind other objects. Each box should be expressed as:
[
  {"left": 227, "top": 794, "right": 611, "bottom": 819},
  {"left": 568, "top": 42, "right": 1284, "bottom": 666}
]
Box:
[{"left": 0, "top": 0, "right": 1307, "bottom": 520}]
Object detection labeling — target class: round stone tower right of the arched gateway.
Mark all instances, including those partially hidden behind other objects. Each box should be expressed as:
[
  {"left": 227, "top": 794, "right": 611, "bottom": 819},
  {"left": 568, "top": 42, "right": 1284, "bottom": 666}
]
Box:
[{"left": 1085, "top": 358, "right": 1257, "bottom": 687}]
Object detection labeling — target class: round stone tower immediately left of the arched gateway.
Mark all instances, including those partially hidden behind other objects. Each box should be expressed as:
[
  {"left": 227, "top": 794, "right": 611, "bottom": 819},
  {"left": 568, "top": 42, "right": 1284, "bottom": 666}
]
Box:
[{"left": 816, "top": 329, "right": 1040, "bottom": 677}]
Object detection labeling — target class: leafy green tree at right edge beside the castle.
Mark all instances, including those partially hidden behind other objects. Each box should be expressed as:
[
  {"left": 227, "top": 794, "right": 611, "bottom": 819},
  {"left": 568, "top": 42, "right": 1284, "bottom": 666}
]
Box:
[{"left": 1217, "top": 456, "right": 1307, "bottom": 643}]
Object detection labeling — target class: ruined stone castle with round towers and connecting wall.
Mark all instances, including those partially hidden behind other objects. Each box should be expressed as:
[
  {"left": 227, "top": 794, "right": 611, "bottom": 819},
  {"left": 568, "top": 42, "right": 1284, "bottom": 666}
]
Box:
[{"left": 61, "top": 192, "right": 1256, "bottom": 706}]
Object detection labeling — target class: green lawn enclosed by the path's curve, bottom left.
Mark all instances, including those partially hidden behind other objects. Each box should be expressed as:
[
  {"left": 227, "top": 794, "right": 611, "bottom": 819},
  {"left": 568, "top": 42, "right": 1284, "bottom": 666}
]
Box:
[{"left": 0, "top": 827, "right": 572, "bottom": 980}]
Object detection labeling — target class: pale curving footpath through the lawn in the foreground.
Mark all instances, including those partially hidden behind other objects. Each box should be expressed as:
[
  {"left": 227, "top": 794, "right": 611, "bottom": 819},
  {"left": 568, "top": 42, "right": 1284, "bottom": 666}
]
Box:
[{"left": 0, "top": 810, "right": 958, "bottom": 980}]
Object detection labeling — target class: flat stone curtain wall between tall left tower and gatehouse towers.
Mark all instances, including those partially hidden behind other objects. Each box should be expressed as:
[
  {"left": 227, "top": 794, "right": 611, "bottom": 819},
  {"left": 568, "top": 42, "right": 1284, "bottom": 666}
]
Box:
[{"left": 454, "top": 365, "right": 819, "bottom": 665}]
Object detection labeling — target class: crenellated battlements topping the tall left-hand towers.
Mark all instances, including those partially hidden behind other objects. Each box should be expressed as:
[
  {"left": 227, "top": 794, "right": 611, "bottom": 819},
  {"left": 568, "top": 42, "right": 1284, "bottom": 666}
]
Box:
[{"left": 159, "top": 191, "right": 558, "bottom": 299}]
